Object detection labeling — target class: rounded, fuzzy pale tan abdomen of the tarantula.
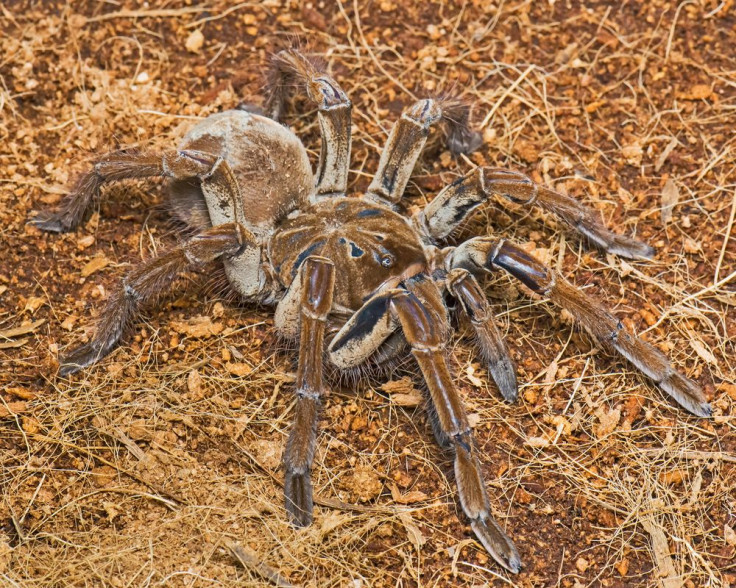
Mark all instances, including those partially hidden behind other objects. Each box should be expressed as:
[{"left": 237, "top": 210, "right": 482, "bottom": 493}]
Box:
[{"left": 171, "top": 110, "right": 313, "bottom": 239}]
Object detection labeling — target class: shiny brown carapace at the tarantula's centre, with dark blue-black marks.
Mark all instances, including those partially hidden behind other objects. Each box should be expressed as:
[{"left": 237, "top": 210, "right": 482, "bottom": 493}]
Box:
[{"left": 268, "top": 198, "right": 427, "bottom": 311}]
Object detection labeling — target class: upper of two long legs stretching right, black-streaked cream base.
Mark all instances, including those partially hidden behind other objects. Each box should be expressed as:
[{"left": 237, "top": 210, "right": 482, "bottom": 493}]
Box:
[{"left": 414, "top": 167, "right": 654, "bottom": 259}]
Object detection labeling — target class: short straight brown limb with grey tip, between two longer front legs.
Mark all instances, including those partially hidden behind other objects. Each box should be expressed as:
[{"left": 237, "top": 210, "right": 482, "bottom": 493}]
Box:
[{"left": 447, "top": 268, "right": 519, "bottom": 402}]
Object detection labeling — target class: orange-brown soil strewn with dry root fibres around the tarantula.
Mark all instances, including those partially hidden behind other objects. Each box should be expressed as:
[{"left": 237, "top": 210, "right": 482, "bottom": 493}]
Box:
[{"left": 0, "top": 0, "right": 736, "bottom": 588}]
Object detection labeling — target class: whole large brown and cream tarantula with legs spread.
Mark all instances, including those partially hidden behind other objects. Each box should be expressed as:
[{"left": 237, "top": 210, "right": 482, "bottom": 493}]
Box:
[{"left": 31, "top": 49, "right": 710, "bottom": 573}]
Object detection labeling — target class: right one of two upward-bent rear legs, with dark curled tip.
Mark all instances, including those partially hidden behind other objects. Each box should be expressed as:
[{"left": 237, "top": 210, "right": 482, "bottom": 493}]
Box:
[{"left": 366, "top": 99, "right": 482, "bottom": 202}]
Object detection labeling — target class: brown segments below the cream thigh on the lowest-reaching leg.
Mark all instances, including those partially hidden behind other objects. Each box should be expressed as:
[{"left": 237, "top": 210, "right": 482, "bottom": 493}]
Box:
[{"left": 391, "top": 291, "right": 521, "bottom": 573}]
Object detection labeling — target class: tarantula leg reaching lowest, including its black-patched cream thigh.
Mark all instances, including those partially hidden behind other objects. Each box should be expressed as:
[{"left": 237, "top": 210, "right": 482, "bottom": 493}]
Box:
[{"left": 328, "top": 283, "right": 521, "bottom": 573}]
